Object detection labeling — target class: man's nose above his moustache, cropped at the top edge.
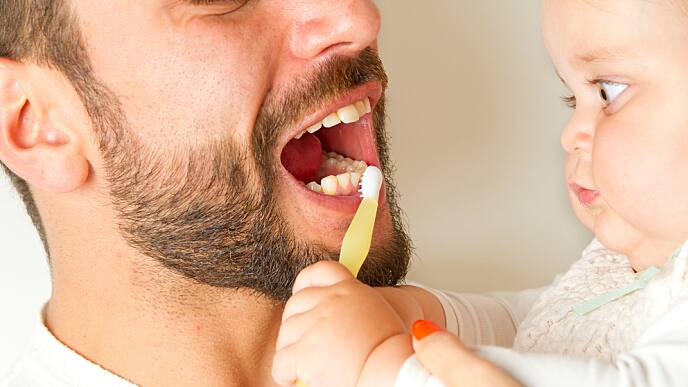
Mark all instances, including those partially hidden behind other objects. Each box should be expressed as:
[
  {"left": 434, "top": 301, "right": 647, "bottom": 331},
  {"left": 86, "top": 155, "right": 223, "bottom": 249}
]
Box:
[{"left": 285, "top": 0, "right": 380, "bottom": 60}]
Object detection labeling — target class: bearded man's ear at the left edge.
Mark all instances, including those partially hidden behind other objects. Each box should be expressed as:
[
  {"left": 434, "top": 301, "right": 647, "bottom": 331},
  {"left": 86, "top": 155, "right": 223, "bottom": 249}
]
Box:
[{"left": 0, "top": 60, "right": 90, "bottom": 193}]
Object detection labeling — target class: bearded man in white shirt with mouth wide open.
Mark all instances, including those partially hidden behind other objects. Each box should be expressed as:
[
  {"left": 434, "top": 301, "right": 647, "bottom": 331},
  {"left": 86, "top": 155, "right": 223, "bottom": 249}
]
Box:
[{"left": 0, "top": 0, "right": 409, "bottom": 387}]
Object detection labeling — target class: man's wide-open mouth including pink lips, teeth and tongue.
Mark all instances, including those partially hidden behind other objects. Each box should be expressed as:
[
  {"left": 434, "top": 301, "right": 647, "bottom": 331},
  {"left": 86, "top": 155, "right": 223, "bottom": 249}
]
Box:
[{"left": 279, "top": 82, "right": 382, "bottom": 212}]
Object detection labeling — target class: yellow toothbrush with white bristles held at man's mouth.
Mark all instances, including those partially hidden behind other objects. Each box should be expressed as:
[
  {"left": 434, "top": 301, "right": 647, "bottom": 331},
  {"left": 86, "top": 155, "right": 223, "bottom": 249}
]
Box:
[{"left": 296, "top": 166, "right": 383, "bottom": 387}]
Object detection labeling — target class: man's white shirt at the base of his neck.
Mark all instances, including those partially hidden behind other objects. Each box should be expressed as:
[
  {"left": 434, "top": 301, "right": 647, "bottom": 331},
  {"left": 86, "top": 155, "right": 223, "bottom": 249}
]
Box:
[{"left": 0, "top": 310, "right": 135, "bottom": 387}]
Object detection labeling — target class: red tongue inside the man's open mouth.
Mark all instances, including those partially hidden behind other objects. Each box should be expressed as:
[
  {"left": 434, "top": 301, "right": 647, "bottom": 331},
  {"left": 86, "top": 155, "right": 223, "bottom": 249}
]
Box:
[{"left": 282, "top": 133, "right": 323, "bottom": 183}]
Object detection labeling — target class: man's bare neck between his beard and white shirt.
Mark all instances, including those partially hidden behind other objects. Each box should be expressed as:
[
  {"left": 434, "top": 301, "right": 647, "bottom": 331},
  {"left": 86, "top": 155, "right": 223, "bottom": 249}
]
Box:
[{"left": 46, "top": 255, "right": 282, "bottom": 386}]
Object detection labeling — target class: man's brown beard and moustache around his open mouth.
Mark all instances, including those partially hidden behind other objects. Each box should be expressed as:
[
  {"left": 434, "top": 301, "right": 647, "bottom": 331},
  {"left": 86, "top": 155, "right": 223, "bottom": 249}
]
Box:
[{"left": 81, "top": 49, "right": 411, "bottom": 301}]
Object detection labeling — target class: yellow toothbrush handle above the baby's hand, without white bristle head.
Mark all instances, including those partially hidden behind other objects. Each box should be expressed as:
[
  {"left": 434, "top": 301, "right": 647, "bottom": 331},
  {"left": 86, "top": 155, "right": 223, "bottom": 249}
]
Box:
[{"left": 339, "top": 198, "right": 377, "bottom": 277}]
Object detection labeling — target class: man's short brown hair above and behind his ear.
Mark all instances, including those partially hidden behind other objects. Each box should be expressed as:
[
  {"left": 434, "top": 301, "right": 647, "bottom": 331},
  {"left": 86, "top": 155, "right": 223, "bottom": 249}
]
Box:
[{"left": 0, "top": 0, "right": 90, "bottom": 252}]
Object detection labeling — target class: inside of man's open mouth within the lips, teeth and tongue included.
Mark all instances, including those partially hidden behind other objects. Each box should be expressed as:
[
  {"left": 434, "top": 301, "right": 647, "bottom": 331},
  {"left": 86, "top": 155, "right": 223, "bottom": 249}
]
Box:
[{"left": 280, "top": 92, "right": 379, "bottom": 196}]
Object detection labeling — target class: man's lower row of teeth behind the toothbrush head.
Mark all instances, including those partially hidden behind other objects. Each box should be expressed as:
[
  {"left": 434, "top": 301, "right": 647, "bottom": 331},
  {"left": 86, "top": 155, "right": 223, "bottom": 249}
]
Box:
[{"left": 306, "top": 152, "right": 368, "bottom": 196}]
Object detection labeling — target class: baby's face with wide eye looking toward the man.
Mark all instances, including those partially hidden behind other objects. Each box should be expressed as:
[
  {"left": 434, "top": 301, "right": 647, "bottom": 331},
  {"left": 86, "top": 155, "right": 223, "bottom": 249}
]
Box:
[{"left": 543, "top": 0, "right": 688, "bottom": 270}]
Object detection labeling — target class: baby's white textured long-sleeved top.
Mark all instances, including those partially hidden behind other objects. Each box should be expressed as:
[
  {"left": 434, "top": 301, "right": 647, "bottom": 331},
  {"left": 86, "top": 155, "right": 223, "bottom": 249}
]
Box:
[{"left": 397, "top": 241, "right": 688, "bottom": 387}]
